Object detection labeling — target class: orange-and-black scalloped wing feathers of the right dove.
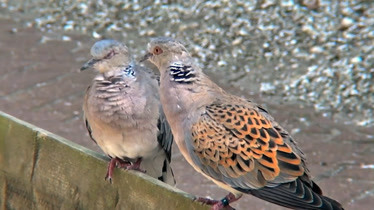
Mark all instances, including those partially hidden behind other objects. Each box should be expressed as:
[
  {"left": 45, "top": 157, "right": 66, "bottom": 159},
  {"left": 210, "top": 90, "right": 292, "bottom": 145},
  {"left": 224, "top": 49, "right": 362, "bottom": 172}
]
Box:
[{"left": 192, "top": 104, "right": 304, "bottom": 186}]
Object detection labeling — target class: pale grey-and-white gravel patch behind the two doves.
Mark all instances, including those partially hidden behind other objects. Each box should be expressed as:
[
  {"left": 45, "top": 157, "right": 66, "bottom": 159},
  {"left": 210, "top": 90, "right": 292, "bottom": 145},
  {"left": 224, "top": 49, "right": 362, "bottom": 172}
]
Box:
[{"left": 0, "top": 0, "right": 374, "bottom": 126}]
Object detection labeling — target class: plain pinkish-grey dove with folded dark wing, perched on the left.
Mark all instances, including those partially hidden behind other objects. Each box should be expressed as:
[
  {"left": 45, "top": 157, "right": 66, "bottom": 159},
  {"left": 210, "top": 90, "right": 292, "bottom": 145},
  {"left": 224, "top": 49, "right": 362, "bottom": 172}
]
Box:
[{"left": 81, "top": 40, "right": 175, "bottom": 185}]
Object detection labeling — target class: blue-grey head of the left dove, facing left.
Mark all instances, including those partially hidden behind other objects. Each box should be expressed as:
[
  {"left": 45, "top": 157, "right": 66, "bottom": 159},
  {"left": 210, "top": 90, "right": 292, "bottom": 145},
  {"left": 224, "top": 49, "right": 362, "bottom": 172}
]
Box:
[{"left": 81, "top": 39, "right": 131, "bottom": 73}]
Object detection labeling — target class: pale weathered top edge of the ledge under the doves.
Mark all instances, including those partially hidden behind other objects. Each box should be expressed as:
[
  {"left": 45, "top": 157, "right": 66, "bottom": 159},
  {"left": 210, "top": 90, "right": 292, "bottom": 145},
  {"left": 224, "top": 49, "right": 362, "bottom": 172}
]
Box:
[{"left": 0, "top": 112, "right": 207, "bottom": 209}]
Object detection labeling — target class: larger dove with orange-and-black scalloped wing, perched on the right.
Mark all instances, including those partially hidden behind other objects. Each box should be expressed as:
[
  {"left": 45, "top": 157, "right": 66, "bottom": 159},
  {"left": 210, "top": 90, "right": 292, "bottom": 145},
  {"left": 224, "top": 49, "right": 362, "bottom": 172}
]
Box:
[{"left": 143, "top": 37, "right": 343, "bottom": 209}]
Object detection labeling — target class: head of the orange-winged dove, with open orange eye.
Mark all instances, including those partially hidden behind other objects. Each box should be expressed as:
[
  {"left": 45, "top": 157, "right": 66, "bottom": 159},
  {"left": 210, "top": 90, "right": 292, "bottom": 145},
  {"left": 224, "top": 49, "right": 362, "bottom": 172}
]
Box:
[{"left": 141, "top": 37, "right": 190, "bottom": 71}]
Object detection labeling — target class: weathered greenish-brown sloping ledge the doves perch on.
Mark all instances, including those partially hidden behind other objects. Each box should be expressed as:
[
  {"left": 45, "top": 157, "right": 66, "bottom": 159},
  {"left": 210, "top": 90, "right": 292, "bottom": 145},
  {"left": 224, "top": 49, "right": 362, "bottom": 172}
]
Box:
[{"left": 0, "top": 112, "right": 208, "bottom": 210}]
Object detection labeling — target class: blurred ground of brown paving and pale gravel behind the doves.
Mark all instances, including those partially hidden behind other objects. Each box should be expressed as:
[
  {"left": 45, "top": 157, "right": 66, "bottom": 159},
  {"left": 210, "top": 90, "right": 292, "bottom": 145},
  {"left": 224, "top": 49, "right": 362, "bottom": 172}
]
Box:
[{"left": 0, "top": 0, "right": 374, "bottom": 209}]
